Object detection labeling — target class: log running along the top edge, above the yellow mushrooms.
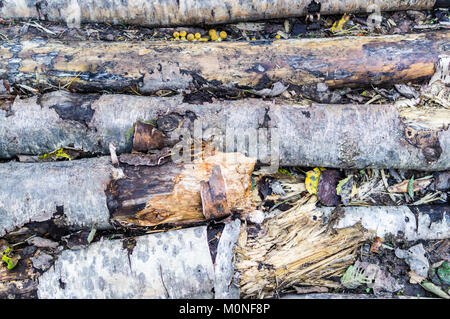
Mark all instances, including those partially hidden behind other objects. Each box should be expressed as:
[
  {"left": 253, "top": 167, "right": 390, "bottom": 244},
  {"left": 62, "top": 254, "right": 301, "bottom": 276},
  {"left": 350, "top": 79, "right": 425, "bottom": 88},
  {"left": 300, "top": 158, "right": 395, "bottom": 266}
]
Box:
[{"left": 0, "top": 0, "right": 439, "bottom": 26}]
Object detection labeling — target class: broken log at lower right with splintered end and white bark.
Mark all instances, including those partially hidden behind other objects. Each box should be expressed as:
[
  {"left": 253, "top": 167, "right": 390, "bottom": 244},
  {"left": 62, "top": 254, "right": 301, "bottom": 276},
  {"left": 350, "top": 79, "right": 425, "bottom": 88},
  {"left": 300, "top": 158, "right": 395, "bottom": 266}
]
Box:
[{"left": 235, "top": 197, "right": 450, "bottom": 297}]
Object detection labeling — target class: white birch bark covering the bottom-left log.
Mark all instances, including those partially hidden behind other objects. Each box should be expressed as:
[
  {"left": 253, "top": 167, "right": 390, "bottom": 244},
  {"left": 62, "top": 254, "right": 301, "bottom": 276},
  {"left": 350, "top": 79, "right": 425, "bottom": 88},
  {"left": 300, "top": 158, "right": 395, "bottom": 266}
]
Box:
[{"left": 38, "top": 222, "right": 239, "bottom": 299}]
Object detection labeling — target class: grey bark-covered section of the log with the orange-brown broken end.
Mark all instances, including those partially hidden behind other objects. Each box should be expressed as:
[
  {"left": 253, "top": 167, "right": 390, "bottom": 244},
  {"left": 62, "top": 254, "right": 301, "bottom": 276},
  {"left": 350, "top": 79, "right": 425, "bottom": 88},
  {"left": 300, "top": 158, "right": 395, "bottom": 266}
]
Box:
[{"left": 0, "top": 157, "right": 113, "bottom": 237}]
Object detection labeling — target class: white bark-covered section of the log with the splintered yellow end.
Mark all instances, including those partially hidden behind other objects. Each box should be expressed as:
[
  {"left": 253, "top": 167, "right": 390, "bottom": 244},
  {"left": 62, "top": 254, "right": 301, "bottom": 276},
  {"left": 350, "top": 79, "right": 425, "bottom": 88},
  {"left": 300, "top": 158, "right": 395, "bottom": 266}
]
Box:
[{"left": 317, "top": 206, "right": 450, "bottom": 241}]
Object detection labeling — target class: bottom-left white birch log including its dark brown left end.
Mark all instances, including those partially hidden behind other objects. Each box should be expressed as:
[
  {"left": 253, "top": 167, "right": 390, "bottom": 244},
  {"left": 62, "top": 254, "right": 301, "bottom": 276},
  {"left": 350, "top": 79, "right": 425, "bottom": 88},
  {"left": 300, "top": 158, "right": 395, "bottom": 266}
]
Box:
[{"left": 0, "top": 219, "right": 240, "bottom": 299}]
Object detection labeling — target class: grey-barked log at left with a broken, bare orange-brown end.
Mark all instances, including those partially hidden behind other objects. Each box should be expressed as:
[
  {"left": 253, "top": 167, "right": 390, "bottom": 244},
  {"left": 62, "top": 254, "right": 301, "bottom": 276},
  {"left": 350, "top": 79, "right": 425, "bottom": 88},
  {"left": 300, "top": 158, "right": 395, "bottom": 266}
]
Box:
[{"left": 0, "top": 153, "right": 255, "bottom": 236}]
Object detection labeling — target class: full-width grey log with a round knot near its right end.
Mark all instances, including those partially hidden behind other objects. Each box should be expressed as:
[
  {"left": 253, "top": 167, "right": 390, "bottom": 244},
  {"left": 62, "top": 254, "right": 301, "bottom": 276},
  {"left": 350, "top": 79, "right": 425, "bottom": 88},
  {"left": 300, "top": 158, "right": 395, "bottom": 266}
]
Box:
[{"left": 0, "top": 91, "right": 450, "bottom": 171}]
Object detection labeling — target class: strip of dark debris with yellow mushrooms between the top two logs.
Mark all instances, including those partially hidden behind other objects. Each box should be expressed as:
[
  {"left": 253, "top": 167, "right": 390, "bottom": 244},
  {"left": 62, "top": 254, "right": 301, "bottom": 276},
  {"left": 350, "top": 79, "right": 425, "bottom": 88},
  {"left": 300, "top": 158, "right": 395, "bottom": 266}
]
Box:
[{"left": 0, "top": 4, "right": 449, "bottom": 42}]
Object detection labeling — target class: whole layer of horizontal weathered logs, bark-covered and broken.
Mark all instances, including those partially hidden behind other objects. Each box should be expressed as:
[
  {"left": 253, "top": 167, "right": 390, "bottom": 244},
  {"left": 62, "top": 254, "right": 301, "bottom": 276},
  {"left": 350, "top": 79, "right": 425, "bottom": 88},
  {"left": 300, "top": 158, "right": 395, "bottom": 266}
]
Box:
[{"left": 0, "top": 0, "right": 450, "bottom": 298}]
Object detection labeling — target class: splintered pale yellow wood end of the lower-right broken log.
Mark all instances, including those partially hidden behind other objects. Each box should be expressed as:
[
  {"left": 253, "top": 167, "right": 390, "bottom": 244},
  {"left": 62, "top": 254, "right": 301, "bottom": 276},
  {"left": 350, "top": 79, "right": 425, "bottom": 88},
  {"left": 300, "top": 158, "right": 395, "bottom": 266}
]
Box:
[{"left": 235, "top": 197, "right": 370, "bottom": 298}]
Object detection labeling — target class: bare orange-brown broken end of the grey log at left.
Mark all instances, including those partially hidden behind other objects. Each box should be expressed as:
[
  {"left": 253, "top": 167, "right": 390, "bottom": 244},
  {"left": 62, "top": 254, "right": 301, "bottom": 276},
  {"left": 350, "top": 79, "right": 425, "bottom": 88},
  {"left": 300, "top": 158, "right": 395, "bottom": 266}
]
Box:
[{"left": 111, "top": 152, "right": 256, "bottom": 226}]
